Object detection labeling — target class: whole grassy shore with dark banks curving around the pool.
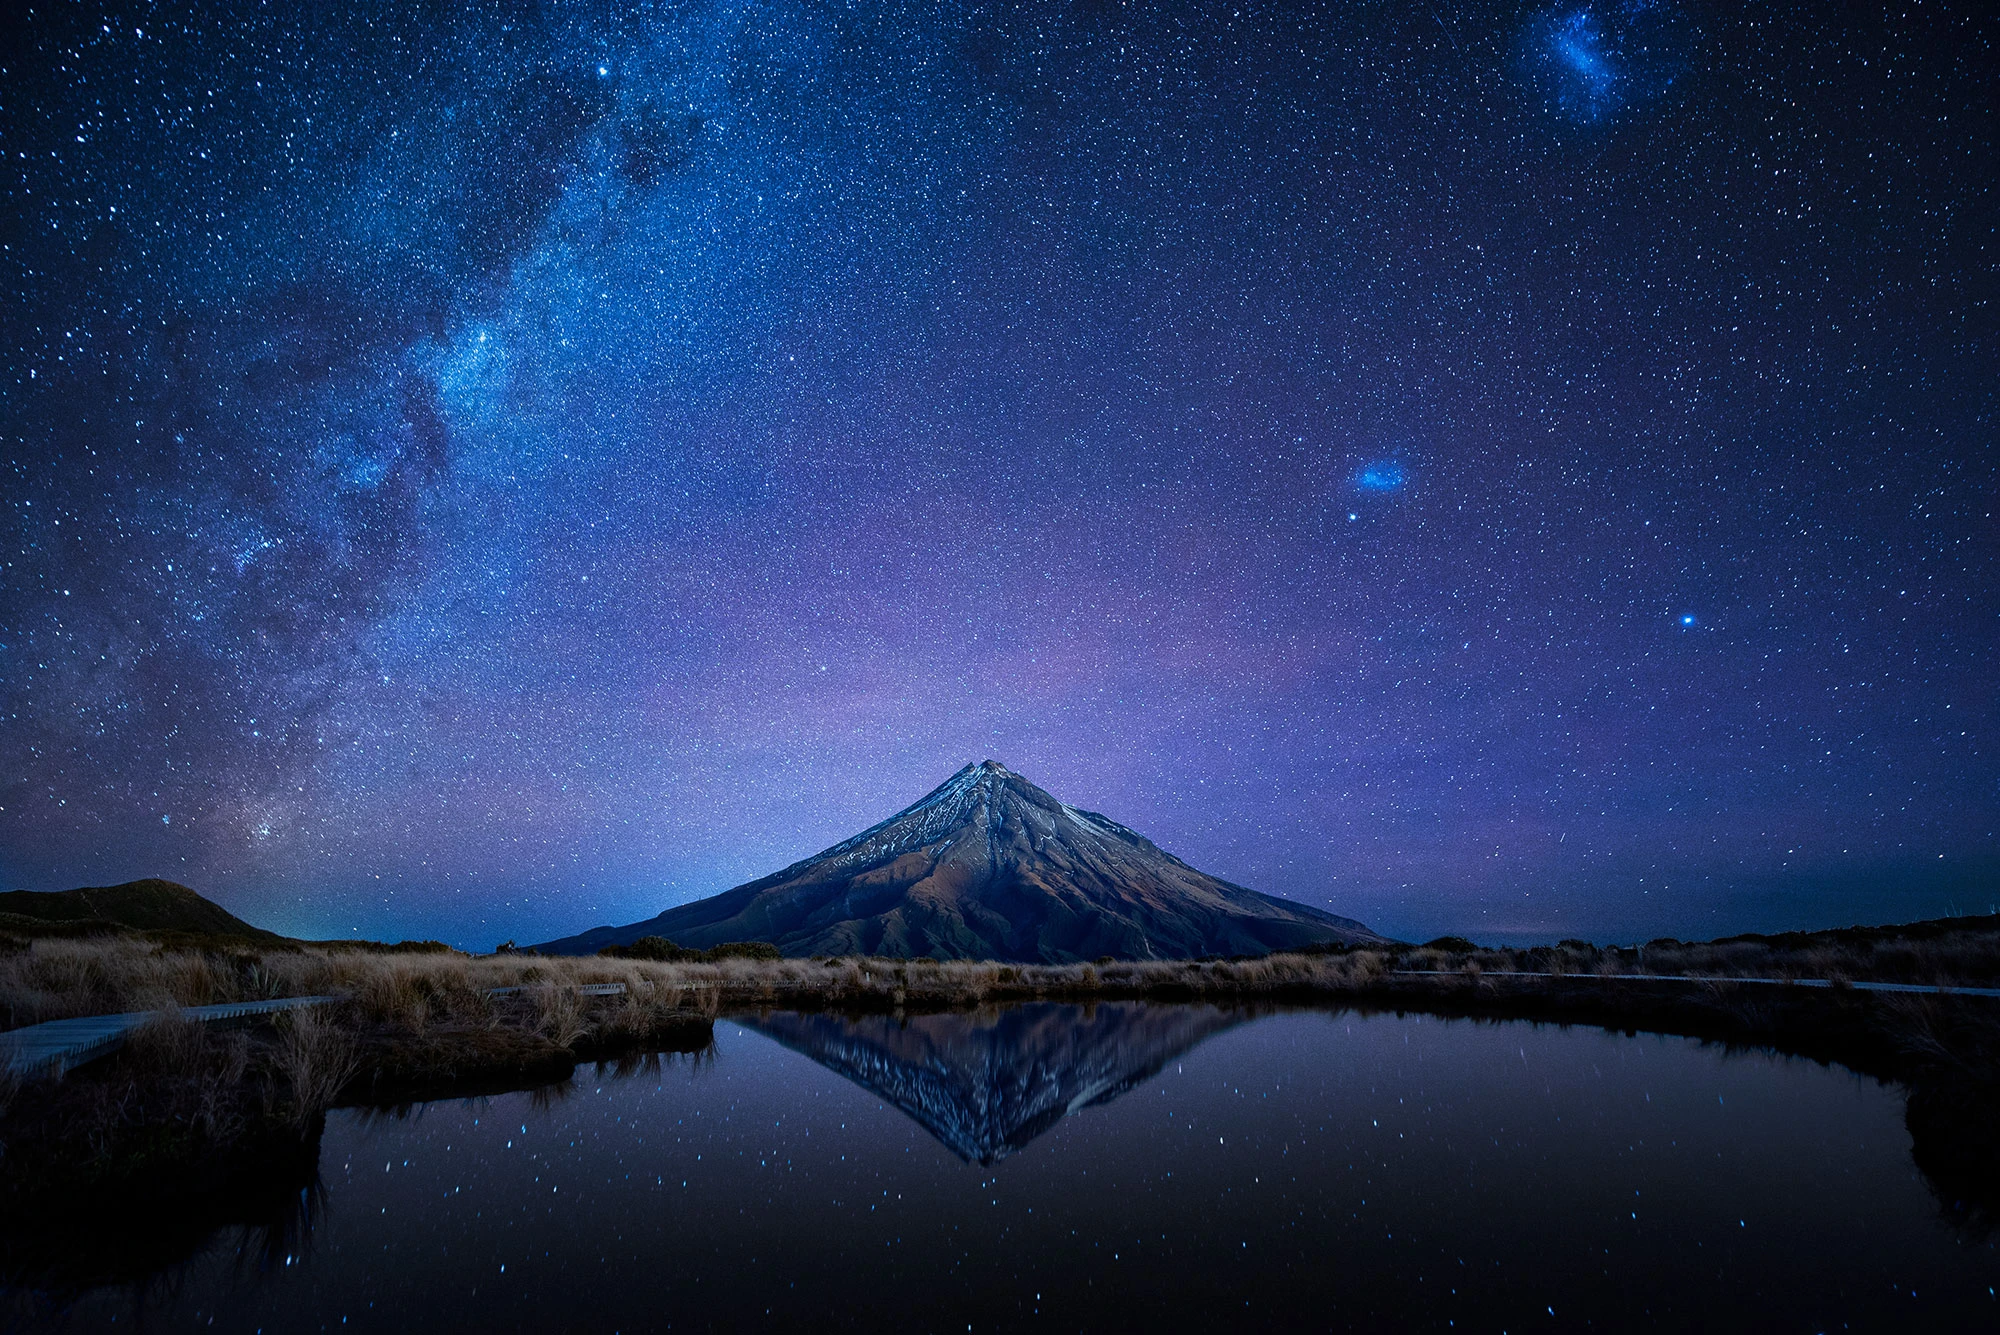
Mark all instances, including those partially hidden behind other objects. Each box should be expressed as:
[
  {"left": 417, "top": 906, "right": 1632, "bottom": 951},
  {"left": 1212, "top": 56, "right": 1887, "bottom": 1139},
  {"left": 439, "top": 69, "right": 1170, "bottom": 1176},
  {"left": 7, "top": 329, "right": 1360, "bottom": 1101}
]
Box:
[{"left": 0, "top": 933, "right": 2000, "bottom": 1283}]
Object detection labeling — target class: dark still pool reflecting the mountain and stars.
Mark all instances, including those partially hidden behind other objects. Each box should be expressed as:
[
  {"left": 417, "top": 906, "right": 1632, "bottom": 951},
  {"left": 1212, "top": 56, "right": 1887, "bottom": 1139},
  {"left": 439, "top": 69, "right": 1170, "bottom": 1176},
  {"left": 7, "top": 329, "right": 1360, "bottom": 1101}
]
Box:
[{"left": 15, "top": 1005, "right": 2000, "bottom": 1331}]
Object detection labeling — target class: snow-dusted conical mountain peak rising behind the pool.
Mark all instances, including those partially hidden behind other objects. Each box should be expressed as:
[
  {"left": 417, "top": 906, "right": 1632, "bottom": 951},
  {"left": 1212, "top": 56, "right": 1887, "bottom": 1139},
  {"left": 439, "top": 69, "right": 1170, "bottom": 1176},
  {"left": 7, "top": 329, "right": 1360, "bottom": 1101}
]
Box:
[{"left": 536, "top": 759, "right": 1386, "bottom": 963}]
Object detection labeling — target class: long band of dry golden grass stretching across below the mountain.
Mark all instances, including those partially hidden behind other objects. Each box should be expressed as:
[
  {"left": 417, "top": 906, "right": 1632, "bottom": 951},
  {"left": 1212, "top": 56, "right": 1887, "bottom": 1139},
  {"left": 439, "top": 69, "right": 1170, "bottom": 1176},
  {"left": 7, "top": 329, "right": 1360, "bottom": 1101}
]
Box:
[{"left": 0, "top": 925, "right": 2000, "bottom": 1047}]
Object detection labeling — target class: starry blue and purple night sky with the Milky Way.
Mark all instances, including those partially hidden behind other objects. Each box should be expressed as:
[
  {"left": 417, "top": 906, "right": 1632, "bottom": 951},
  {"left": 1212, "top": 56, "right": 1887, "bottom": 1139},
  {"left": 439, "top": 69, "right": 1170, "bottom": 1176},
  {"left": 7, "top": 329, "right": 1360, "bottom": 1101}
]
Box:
[{"left": 0, "top": 0, "right": 2000, "bottom": 947}]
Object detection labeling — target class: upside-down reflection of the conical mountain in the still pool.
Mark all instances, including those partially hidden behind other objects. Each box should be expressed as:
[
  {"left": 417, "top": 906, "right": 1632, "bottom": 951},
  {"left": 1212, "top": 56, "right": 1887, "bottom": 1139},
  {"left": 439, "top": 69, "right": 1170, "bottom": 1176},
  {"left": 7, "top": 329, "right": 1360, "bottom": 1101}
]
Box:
[{"left": 738, "top": 1001, "right": 1242, "bottom": 1163}]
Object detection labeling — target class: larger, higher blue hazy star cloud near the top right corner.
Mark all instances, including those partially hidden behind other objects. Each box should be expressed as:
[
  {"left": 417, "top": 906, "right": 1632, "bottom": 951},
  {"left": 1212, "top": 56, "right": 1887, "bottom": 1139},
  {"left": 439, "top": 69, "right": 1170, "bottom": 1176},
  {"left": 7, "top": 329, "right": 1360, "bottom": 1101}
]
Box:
[{"left": 1522, "top": 0, "right": 1688, "bottom": 124}]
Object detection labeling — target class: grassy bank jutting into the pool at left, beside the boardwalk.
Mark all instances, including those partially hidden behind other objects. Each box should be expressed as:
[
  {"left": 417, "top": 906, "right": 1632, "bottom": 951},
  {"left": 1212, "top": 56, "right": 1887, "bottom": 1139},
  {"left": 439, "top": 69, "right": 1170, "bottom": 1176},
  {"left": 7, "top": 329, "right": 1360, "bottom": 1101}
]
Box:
[{"left": 0, "top": 935, "right": 720, "bottom": 1227}]
